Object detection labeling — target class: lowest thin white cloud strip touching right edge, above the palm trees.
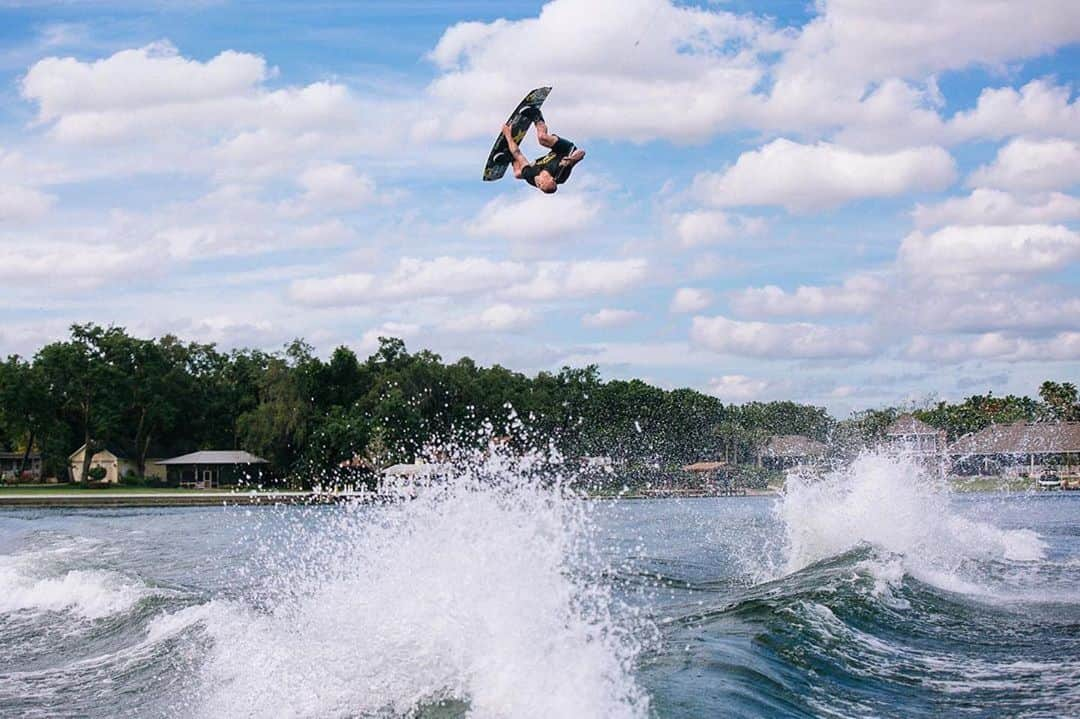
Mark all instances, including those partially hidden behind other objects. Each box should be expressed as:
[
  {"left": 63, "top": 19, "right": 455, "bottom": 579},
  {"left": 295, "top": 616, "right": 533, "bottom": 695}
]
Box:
[{"left": 906, "top": 331, "right": 1080, "bottom": 363}]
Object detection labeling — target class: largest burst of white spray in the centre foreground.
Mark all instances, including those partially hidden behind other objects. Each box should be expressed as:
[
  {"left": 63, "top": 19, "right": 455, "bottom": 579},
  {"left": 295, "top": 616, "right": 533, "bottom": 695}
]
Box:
[{"left": 185, "top": 449, "right": 648, "bottom": 719}]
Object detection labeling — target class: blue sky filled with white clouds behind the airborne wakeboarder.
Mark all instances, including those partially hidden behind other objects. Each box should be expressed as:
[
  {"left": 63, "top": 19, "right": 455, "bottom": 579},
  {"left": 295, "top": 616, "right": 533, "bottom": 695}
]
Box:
[{"left": 0, "top": 0, "right": 1080, "bottom": 415}]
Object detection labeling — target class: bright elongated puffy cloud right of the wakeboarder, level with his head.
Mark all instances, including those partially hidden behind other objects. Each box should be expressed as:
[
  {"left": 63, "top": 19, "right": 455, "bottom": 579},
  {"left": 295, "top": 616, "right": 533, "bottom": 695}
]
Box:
[{"left": 694, "top": 139, "right": 956, "bottom": 212}]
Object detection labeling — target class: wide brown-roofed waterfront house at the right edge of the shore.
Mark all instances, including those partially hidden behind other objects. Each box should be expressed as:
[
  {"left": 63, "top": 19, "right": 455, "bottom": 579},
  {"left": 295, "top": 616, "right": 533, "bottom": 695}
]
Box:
[{"left": 948, "top": 422, "right": 1080, "bottom": 476}]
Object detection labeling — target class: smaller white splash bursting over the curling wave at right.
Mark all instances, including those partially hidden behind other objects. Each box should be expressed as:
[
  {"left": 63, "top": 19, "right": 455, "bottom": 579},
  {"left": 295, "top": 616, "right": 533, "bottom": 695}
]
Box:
[{"left": 775, "top": 453, "right": 1045, "bottom": 594}]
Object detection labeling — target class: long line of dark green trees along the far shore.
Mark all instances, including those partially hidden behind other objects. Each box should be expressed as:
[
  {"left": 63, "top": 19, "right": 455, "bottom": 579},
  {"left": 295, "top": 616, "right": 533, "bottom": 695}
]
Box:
[{"left": 0, "top": 324, "right": 1080, "bottom": 484}]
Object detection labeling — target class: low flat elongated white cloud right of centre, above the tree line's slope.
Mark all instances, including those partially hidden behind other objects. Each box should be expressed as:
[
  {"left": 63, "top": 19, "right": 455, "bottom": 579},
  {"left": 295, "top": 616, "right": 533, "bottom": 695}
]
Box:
[{"left": 690, "top": 316, "right": 877, "bottom": 358}]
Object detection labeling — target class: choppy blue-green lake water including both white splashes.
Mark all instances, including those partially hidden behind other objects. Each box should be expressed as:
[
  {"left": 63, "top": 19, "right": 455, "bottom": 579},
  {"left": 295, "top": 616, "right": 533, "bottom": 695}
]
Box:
[{"left": 0, "top": 457, "right": 1080, "bottom": 719}]
